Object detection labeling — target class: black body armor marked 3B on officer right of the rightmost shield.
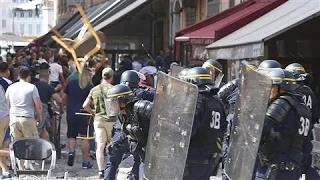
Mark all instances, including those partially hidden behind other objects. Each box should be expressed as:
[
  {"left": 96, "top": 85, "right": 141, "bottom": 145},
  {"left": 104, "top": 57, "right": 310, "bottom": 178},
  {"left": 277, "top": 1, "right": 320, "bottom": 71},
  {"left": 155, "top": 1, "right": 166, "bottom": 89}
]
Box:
[{"left": 259, "top": 95, "right": 311, "bottom": 165}]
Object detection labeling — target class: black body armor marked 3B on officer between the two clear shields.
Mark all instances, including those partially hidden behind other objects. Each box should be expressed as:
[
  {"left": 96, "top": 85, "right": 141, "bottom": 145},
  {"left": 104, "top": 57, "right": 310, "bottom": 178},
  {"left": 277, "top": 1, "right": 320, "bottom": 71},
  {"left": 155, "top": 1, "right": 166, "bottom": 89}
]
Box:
[{"left": 190, "top": 92, "right": 227, "bottom": 156}]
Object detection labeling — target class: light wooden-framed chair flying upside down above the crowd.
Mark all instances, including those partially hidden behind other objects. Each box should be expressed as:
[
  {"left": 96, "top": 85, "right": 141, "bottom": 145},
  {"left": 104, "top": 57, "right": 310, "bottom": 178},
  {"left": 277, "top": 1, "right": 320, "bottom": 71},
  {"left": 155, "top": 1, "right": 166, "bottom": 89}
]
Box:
[{"left": 52, "top": 5, "right": 106, "bottom": 88}]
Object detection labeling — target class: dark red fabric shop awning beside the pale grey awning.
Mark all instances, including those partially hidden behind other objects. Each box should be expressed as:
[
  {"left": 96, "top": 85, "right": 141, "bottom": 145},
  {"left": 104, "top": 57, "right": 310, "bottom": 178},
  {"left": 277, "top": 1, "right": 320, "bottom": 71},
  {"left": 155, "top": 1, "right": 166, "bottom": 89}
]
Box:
[{"left": 175, "top": 0, "right": 287, "bottom": 45}]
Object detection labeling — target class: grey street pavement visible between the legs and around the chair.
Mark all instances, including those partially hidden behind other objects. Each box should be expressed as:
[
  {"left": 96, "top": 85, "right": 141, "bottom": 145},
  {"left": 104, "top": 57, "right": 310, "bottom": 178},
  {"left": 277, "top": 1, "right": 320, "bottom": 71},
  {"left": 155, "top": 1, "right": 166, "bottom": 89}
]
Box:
[{"left": 12, "top": 113, "right": 221, "bottom": 180}]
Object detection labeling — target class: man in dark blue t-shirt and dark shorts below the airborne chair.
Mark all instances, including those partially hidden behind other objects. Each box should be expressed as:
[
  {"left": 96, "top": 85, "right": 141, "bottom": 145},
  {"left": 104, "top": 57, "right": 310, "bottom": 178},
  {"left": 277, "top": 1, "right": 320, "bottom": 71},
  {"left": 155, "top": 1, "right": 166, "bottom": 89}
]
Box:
[{"left": 65, "top": 79, "right": 93, "bottom": 169}]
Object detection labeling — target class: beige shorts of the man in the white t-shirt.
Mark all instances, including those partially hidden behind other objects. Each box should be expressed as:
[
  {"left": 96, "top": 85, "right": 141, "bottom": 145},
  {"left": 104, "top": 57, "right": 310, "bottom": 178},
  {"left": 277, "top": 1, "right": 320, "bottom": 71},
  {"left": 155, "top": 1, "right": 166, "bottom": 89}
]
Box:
[{"left": 10, "top": 117, "right": 39, "bottom": 140}]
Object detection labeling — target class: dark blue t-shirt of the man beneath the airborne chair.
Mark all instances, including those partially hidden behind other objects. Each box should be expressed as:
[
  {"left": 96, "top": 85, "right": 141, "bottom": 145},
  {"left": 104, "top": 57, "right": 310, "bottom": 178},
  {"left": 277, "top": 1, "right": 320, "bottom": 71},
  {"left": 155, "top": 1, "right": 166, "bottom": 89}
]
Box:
[{"left": 64, "top": 79, "right": 93, "bottom": 118}]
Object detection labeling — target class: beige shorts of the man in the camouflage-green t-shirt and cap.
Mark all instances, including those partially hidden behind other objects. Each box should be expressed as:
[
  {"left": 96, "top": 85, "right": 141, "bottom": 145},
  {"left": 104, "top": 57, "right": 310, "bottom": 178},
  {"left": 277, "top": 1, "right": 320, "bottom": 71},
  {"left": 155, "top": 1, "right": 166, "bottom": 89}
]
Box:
[{"left": 93, "top": 121, "right": 115, "bottom": 143}]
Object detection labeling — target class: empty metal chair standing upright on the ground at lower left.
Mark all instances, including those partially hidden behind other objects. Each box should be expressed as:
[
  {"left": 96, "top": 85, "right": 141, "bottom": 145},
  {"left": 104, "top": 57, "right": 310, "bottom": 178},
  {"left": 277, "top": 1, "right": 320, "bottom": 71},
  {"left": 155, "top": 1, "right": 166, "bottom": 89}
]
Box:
[{"left": 9, "top": 138, "right": 56, "bottom": 180}]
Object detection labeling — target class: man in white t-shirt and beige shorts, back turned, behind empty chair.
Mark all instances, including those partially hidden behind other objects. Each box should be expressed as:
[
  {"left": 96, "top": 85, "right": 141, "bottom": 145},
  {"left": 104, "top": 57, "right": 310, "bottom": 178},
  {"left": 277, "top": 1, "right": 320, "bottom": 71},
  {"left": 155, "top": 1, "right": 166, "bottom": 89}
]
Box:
[{"left": 6, "top": 67, "right": 42, "bottom": 140}]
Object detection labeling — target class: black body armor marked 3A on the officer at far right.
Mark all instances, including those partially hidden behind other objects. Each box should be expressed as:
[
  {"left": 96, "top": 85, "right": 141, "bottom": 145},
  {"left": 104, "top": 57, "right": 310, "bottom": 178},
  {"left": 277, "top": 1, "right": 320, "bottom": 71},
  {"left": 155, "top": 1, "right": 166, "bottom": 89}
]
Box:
[{"left": 295, "top": 85, "right": 319, "bottom": 124}]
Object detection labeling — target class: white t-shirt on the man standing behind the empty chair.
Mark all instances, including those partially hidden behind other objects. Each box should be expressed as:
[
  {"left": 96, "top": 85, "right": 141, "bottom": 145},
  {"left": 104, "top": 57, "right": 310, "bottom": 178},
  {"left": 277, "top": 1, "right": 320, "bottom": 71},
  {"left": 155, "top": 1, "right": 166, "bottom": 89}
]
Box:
[{"left": 6, "top": 81, "right": 39, "bottom": 118}]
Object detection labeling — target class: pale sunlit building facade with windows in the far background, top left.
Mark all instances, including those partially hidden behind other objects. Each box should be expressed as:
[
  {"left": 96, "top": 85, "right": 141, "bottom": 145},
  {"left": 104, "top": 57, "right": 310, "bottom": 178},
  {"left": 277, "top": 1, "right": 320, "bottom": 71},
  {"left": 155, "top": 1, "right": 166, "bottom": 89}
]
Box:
[{"left": 0, "top": 0, "right": 55, "bottom": 40}]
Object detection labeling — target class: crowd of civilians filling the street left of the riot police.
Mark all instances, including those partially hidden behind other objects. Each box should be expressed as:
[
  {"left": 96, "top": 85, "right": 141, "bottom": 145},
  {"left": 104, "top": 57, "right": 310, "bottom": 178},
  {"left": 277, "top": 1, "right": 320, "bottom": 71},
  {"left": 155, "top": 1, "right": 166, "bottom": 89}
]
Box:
[{"left": 0, "top": 46, "right": 172, "bottom": 179}]
